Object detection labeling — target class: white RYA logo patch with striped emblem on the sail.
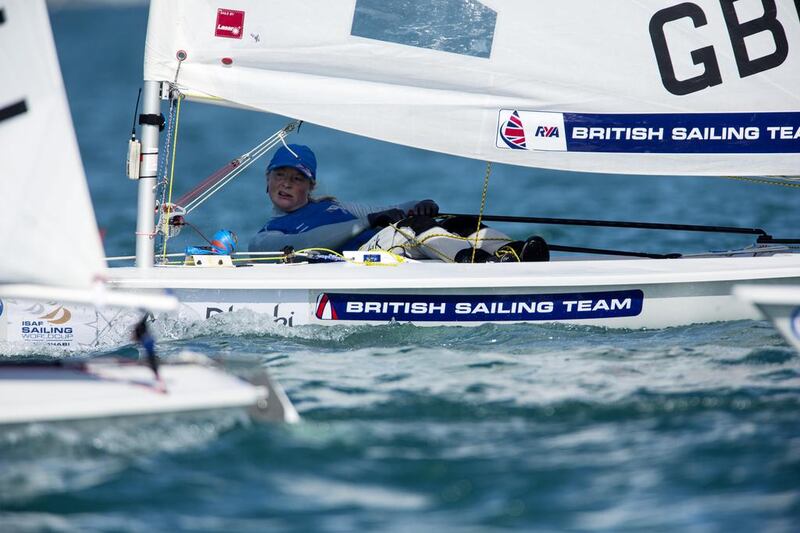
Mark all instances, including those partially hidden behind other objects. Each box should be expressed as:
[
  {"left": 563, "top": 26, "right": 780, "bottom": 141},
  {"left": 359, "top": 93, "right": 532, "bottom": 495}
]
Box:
[{"left": 495, "top": 109, "right": 567, "bottom": 152}]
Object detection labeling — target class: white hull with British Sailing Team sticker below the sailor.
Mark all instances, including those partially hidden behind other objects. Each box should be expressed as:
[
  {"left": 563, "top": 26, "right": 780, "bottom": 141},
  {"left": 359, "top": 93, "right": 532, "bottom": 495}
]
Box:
[{"left": 0, "top": 254, "right": 800, "bottom": 347}]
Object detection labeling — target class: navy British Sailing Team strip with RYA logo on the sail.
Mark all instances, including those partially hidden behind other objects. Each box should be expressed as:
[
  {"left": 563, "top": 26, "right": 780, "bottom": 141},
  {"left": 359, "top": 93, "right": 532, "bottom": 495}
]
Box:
[{"left": 497, "top": 109, "right": 800, "bottom": 154}]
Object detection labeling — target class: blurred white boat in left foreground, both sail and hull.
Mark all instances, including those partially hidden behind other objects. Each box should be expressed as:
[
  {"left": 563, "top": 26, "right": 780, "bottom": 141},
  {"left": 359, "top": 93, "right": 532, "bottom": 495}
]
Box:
[{"left": 0, "top": 0, "right": 298, "bottom": 426}]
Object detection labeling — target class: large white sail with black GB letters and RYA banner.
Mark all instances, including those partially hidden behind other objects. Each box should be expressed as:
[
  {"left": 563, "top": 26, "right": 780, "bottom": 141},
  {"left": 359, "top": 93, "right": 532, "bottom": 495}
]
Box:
[{"left": 144, "top": 0, "right": 800, "bottom": 175}]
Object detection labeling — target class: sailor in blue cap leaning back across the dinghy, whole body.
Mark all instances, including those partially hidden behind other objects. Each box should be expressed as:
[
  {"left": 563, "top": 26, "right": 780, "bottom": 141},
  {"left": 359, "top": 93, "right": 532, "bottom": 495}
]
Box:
[{"left": 248, "top": 144, "right": 549, "bottom": 262}]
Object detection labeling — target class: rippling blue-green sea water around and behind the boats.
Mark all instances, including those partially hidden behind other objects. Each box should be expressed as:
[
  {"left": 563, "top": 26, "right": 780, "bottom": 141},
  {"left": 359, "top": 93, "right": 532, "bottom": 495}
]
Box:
[{"left": 0, "top": 2, "right": 800, "bottom": 532}]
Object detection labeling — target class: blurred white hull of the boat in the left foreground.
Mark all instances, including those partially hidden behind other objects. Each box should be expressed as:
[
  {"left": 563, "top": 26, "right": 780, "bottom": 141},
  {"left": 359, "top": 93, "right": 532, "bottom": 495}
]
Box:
[{"left": 0, "top": 359, "right": 299, "bottom": 426}]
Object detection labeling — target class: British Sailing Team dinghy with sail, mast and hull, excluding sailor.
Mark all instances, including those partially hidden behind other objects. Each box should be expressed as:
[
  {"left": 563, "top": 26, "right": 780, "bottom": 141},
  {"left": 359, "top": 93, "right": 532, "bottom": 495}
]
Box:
[{"left": 8, "top": 0, "right": 800, "bottom": 343}]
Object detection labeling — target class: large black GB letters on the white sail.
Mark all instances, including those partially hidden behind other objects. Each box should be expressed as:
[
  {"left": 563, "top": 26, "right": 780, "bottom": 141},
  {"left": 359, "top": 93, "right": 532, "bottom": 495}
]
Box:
[{"left": 650, "top": 0, "right": 800, "bottom": 96}]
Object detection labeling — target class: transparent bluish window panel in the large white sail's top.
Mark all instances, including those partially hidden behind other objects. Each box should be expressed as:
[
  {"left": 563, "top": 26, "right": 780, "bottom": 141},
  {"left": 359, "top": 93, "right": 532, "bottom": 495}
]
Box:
[{"left": 351, "top": 0, "right": 497, "bottom": 58}]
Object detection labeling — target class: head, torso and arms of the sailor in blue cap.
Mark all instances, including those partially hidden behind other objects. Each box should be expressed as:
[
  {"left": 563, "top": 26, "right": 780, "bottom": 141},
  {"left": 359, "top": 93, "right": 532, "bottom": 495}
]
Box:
[{"left": 248, "top": 144, "right": 439, "bottom": 252}]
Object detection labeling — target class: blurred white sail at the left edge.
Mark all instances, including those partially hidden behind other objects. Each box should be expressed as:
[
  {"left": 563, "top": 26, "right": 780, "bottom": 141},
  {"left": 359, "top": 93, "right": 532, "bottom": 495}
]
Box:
[{"left": 0, "top": 0, "right": 105, "bottom": 287}]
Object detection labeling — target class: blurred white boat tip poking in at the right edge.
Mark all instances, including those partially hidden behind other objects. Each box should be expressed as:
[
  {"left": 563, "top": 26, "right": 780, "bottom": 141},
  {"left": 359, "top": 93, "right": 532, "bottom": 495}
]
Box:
[{"left": 734, "top": 285, "right": 800, "bottom": 352}]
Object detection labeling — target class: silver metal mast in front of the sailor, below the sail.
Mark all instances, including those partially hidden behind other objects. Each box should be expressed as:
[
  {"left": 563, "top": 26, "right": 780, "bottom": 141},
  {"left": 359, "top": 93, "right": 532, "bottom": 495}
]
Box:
[{"left": 136, "top": 81, "right": 161, "bottom": 268}]
